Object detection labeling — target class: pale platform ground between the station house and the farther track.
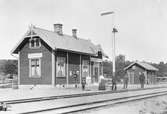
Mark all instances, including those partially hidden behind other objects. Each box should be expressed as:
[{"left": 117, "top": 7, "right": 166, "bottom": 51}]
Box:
[{"left": 0, "top": 84, "right": 167, "bottom": 101}]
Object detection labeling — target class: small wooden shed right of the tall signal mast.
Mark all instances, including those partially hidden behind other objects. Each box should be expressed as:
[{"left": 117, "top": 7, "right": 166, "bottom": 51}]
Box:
[{"left": 124, "top": 62, "right": 158, "bottom": 84}]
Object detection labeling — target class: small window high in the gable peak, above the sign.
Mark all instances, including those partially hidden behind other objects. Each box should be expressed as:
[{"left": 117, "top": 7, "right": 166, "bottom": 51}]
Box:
[{"left": 29, "top": 38, "right": 41, "bottom": 48}]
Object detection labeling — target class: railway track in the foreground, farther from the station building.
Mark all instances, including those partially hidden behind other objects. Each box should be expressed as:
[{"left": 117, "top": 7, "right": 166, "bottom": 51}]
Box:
[{"left": 20, "top": 90, "right": 167, "bottom": 114}]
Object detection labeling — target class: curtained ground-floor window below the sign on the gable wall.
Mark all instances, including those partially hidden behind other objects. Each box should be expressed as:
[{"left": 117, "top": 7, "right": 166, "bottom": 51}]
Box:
[{"left": 29, "top": 58, "right": 41, "bottom": 77}]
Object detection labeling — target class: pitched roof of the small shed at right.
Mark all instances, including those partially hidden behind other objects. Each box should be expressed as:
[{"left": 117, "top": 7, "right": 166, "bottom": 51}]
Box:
[{"left": 124, "top": 61, "right": 158, "bottom": 71}]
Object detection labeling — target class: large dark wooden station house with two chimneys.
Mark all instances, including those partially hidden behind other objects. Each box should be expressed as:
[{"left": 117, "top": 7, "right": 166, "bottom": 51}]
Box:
[{"left": 12, "top": 24, "right": 105, "bottom": 86}]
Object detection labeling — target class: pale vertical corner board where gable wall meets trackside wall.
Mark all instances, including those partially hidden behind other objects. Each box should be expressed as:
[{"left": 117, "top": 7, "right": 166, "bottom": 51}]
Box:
[{"left": 52, "top": 51, "right": 55, "bottom": 86}]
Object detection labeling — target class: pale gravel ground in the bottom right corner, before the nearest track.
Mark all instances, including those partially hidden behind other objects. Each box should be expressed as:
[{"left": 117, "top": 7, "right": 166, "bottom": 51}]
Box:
[{"left": 82, "top": 96, "right": 167, "bottom": 114}]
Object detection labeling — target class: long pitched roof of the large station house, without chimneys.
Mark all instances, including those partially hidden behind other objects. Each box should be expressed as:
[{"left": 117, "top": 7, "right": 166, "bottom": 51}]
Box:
[{"left": 12, "top": 27, "right": 105, "bottom": 56}]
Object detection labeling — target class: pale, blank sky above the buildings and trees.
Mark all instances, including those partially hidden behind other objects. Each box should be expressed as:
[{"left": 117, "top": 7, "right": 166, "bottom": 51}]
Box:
[{"left": 0, "top": 0, "right": 167, "bottom": 63}]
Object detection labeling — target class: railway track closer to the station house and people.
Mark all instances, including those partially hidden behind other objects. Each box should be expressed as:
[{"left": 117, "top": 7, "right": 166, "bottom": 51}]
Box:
[{"left": 0, "top": 86, "right": 167, "bottom": 104}]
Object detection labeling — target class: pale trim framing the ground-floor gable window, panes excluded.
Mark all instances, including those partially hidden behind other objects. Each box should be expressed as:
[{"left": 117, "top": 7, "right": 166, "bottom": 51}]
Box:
[{"left": 29, "top": 58, "right": 41, "bottom": 78}]
